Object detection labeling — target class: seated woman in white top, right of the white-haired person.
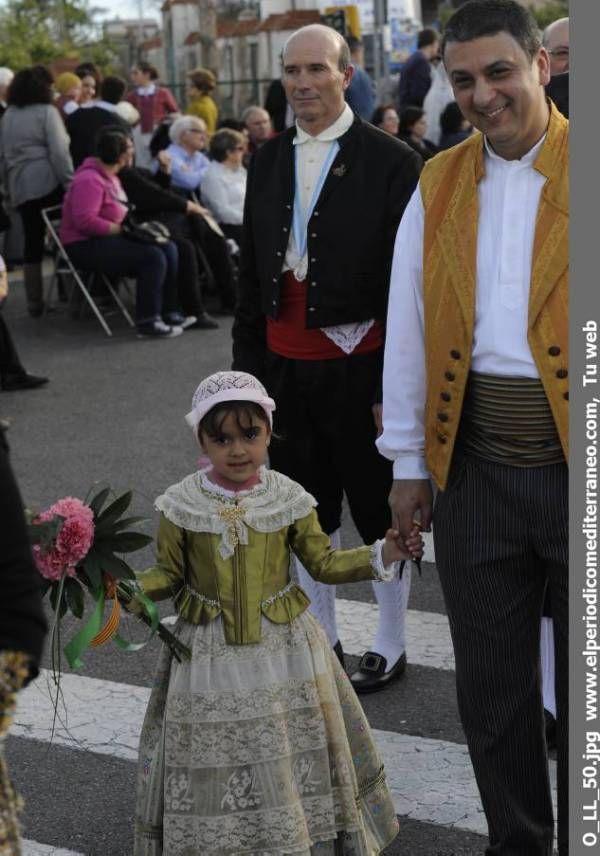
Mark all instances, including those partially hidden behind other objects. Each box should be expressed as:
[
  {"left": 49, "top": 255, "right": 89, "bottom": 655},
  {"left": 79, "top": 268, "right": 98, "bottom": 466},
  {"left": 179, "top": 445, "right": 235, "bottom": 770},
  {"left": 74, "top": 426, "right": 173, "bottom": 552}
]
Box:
[{"left": 202, "top": 128, "right": 247, "bottom": 246}]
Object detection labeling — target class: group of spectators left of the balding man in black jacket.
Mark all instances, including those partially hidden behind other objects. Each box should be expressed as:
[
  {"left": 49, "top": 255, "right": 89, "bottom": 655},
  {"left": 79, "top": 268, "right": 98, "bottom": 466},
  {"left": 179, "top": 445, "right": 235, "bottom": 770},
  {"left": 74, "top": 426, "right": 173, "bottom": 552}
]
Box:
[{"left": 0, "top": 62, "right": 251, "bottom": 348}]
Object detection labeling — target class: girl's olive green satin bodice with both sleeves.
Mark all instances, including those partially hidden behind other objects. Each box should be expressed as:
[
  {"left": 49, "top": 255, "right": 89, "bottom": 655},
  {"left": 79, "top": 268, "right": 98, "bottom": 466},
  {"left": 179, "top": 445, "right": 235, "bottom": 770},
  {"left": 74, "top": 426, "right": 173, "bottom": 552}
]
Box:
[{"left": 137, "top": 509, "right": 376, "bottom": 645}]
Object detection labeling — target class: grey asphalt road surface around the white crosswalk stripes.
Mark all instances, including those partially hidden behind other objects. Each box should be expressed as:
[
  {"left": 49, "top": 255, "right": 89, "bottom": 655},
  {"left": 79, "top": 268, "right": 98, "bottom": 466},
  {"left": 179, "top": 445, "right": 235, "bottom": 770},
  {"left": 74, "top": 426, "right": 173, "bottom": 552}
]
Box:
[{"left": 0, "top": 276, "right": 492, "bottom": 856}]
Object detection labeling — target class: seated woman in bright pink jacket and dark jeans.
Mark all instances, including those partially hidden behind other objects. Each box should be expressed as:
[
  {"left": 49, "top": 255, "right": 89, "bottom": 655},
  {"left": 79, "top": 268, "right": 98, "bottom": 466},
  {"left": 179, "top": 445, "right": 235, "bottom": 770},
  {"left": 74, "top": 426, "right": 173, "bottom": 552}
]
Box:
[{"left": 60, "top": 127, "right": 183, "bottom": 339}]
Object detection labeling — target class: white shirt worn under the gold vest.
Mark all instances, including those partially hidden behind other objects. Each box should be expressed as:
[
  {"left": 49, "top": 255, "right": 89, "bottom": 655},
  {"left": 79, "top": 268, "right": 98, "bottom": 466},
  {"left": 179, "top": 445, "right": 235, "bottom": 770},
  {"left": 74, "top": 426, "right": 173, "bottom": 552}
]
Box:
[{"left": 377, "top": 138, "right": 546, "bottom": 479}]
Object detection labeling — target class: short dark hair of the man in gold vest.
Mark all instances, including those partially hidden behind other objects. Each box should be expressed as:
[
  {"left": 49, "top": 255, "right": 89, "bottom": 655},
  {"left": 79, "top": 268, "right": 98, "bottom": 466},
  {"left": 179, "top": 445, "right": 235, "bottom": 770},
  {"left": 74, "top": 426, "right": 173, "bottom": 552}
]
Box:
[{"left": 442, "top": 0, "right": 542, "bottom": 59}]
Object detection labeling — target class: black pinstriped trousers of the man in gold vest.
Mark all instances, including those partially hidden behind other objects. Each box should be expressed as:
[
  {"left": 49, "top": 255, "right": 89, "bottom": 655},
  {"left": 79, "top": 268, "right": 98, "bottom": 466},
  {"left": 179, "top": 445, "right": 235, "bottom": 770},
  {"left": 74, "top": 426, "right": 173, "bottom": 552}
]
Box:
[{"left": 434, "top": 452, "right": 568, "bottom": 856}]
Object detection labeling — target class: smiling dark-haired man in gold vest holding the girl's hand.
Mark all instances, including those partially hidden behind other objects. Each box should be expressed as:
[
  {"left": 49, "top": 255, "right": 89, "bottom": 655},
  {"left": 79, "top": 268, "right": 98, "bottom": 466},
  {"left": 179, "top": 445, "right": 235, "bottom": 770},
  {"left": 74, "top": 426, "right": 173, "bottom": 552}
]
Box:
[{"left": 378, "top": 0, "right": 568, "bottom": 856}]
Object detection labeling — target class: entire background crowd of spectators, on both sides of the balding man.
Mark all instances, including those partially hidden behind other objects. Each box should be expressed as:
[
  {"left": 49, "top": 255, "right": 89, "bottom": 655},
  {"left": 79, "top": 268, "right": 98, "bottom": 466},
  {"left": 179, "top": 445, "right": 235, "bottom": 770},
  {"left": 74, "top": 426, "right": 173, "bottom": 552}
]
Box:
[{"left": 0, "top": 21, "right": 568, "bottom": 354}]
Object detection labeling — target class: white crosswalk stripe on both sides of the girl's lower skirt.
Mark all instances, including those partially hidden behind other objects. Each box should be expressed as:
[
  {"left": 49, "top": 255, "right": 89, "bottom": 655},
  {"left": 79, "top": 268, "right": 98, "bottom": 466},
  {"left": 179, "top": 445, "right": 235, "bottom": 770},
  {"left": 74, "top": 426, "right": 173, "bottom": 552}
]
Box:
[{"left": 12, "top": 671, "right": 555, "bottom": 844}]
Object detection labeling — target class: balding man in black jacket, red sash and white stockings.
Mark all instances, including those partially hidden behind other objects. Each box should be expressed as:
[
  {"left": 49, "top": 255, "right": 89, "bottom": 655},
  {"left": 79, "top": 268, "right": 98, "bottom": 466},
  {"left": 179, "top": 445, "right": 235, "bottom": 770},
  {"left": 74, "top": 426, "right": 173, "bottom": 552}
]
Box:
[{"left": 233, "top": 24, "right": 421, "bottom": 692}]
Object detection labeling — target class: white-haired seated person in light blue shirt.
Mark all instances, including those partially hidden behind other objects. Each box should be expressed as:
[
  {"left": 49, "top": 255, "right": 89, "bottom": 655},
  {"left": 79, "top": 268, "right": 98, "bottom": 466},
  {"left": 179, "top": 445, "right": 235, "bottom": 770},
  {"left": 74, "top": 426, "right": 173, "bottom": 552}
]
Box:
[{"left": 165, "top": 116, "right": 210, "bottom": 198}]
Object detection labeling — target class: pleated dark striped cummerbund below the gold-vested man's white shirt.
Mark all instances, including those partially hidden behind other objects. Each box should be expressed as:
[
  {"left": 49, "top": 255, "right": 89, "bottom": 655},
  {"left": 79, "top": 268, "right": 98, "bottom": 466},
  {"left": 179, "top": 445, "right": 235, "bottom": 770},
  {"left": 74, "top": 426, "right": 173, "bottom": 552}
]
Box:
[{"left": 459, "top": 372, "right": 565, "bottom": 467}]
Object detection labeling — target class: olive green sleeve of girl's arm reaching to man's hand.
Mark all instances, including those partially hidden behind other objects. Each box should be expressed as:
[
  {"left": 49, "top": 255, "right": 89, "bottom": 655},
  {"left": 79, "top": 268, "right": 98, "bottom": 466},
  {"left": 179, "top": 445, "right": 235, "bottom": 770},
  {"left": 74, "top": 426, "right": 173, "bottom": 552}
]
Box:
[{"left": 289, "top": 509, "right": 377, "bottom": 585}]
